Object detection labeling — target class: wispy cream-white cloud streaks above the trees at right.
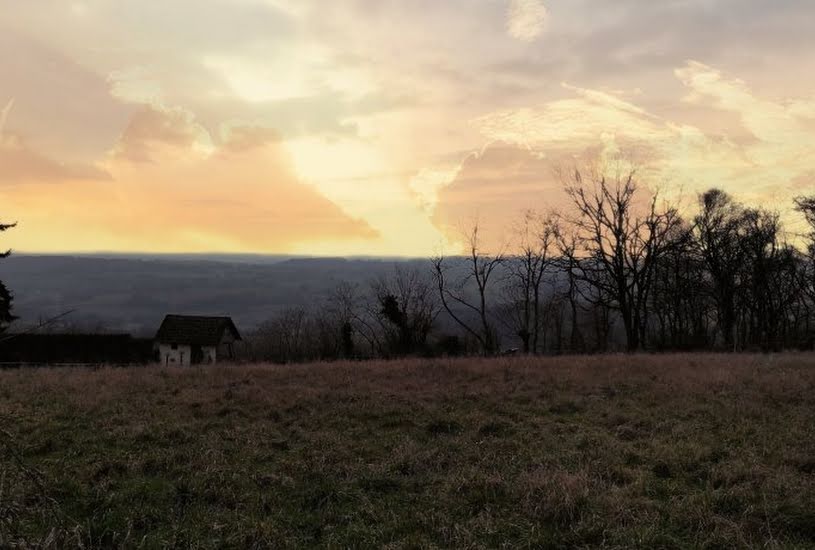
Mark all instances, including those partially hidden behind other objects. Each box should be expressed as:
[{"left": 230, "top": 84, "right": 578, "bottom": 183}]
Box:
[{"left": 456, "top": 62, "right": 815, "bottom": 225}]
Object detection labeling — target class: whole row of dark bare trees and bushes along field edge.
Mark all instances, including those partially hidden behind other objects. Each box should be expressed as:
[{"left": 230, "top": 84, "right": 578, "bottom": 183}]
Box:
[{"left": 247, "top": 169, "right": 815, "bottom": 362}]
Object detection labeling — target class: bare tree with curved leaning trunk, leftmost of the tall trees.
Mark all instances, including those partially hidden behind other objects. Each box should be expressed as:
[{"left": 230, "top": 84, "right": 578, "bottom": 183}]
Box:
[{"left": 431, "top": 222, "right": 506, "bottom": 355}]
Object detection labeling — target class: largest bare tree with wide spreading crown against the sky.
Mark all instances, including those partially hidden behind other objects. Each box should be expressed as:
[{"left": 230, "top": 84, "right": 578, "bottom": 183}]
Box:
[{"left": 566, "top": 168, "right": 681, "bottom": 352}]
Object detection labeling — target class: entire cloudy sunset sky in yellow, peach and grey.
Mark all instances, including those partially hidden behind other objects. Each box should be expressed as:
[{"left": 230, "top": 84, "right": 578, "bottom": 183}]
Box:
[{"left": 0, "top": 0, "right": 815, "bottom": 256}]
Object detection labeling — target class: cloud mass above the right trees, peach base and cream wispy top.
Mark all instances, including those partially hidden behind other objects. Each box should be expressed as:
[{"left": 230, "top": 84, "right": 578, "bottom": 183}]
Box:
[{"left": 433, "top": 61, "right": 815, "bottom": 249}]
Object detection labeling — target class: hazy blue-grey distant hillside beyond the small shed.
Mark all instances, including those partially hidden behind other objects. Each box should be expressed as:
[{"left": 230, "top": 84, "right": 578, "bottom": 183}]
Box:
[{"left": 0, "top": 255, "right": 428, "bottom": 335}]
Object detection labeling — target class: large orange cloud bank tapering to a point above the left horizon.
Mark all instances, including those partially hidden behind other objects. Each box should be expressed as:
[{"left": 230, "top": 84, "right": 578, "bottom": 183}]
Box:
[{"left": 0, "top": 108, "right": 377, "bottom": 252}]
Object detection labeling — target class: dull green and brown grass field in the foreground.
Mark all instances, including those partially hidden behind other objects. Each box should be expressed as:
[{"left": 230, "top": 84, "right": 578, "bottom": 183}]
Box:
[{"left": 0, "top": 355, "right": 815, "bottom": 548}]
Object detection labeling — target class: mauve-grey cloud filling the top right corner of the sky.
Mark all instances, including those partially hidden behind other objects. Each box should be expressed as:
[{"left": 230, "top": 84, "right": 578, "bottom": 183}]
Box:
[{"left": 488, "top": 0, "right": 815, "bottom": 98}]
